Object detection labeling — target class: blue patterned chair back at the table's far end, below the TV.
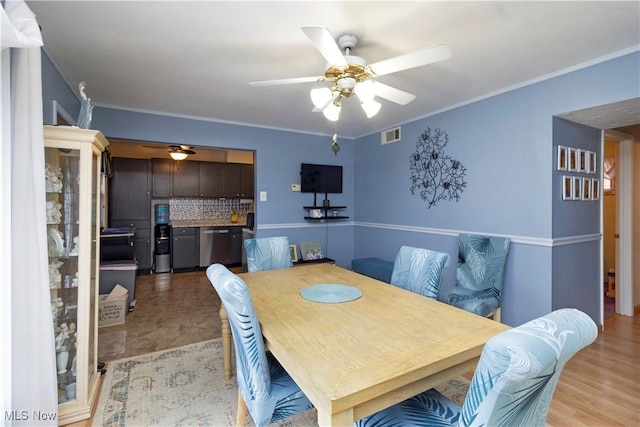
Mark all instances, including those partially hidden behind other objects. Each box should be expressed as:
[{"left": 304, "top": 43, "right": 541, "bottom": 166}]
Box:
[{"left": 244, "top": 236, "right": 293, "bottom": 272}]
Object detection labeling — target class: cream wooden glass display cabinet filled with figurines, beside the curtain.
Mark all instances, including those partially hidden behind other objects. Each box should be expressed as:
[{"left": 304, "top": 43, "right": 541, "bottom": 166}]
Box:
[{"left": 44, "top": 126, "right": 109, "bottom": 424}]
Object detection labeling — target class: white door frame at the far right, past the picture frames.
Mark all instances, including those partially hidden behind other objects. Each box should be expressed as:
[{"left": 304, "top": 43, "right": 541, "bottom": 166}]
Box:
[{"left": 601, "top": 130, "right": 634, "bottom": 316}]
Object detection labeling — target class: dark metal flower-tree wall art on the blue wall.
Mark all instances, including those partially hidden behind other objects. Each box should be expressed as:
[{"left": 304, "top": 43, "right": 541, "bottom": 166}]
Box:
[{"left": 409, "top": 128, "right": 467, "bottom": 209}]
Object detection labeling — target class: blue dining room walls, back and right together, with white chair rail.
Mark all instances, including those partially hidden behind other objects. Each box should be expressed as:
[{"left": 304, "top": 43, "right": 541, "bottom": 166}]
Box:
[{"left": 43, "top": 52, "right": 640, "bottom": 325}]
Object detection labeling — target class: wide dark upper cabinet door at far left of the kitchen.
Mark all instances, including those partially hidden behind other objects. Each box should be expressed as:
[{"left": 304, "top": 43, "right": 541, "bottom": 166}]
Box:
[{"left": 109, "top": 157, "right": 151, "bottom": 221}]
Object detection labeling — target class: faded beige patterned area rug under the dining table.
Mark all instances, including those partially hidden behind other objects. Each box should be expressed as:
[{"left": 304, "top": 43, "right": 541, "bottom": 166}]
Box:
[{"left": 92, "top": 338, "right": 469, "bottom": 427}]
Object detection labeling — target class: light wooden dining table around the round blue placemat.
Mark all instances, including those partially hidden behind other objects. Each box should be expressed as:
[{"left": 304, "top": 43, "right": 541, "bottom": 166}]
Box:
[{"left": 220, "top": 264, "right": 509, "bottom": 426}]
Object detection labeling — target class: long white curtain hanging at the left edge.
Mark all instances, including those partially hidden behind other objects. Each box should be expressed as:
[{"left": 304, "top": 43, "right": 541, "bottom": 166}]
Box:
[{"left": 0, "top": 0, "right": 58, "bottom": 426}]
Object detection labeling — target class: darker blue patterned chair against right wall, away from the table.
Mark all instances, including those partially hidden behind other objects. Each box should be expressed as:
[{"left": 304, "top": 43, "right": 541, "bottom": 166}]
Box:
[{"left": 440, "top": 234, "right": 510, "bottom": 322}]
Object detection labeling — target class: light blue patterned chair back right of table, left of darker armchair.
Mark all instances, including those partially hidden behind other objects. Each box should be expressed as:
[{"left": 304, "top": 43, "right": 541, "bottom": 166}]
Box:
[{"left": 391, "top": 246, "right": 449, "bottom": 299}]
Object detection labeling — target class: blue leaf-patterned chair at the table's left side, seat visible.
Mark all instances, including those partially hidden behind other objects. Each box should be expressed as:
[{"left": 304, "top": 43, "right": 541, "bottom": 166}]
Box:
[{"left": 207, "top": 264, "right": 313, "bottom": 427}]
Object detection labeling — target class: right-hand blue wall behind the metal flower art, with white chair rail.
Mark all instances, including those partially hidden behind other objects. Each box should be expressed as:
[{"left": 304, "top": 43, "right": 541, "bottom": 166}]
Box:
[{"left": 354, "top": 52, "right": 640, "bottom": 325}]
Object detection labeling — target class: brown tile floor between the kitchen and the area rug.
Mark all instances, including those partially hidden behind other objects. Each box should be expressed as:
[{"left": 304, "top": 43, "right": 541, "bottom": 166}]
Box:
[{"left": 98, "top": 271, "right": 226, "bottom": 362}]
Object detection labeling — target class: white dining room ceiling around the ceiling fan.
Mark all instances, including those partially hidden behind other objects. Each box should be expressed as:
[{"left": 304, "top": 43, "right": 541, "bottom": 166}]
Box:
[{"left": 27, "top": 1, "right": 640, "bottom": 137}]
